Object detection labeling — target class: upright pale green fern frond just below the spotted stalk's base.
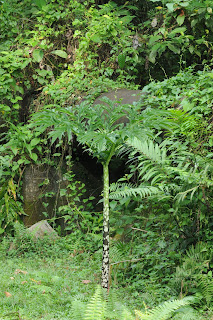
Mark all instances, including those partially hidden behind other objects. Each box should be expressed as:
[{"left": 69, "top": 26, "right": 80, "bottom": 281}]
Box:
[{"left": 84, "top": 286, "right": 106, "bottom": 320}]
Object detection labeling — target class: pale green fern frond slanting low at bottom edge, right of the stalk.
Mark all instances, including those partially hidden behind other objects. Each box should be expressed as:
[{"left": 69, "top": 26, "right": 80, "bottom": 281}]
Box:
[{"left": 135, "top": 297, "right": 195, "bottom": 320}]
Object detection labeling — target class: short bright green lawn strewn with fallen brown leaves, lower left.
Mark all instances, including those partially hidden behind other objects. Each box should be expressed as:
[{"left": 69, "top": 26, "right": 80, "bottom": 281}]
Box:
[{"left": 0, "top": 257, "right": 97, "bottom": 320}]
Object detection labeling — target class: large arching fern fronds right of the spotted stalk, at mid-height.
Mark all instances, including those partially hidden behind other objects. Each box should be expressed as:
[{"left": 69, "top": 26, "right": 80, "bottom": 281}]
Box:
[{"left": 111, "top": 136, "right": 213, "bottom": 204}]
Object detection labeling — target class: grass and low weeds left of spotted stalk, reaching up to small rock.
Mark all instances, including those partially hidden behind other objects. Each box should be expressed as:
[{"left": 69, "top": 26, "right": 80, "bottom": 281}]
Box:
[{"left": 0, "top": 232, "right": 104, "bottom": 320}]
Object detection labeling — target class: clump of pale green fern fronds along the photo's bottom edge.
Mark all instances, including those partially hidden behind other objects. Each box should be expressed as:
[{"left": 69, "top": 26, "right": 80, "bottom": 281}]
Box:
[{"left": 70, "top": 286, "right": 199, "bottom": 320}]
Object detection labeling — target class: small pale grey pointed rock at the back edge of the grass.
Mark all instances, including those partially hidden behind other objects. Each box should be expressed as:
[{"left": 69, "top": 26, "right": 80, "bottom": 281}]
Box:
[{"left": 28, "top": 220, "right": 58, "bottom": 239}]
